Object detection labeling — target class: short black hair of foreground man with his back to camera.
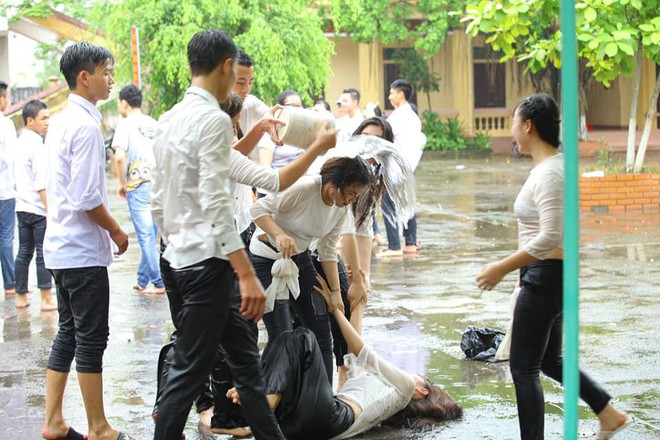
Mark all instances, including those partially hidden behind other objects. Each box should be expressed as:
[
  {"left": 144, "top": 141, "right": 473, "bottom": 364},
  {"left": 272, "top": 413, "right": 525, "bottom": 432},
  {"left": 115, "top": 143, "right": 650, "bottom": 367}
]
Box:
[{"left": 188, "top": 29, "right": 238, "bottom": 76}]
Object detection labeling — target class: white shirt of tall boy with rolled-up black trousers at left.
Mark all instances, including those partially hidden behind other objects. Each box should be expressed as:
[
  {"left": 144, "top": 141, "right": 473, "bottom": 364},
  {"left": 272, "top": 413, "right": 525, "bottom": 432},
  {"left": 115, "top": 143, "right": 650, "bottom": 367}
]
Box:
[{"left": 44, "top": 93, "right": 112, "bottom": 269}]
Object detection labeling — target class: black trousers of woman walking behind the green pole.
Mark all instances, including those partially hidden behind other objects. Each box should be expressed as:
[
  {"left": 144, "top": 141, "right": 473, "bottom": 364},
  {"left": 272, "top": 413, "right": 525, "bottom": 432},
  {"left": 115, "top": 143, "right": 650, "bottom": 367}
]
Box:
[{"left": 510, "top": 260, "right": 611, "bottom": 440}]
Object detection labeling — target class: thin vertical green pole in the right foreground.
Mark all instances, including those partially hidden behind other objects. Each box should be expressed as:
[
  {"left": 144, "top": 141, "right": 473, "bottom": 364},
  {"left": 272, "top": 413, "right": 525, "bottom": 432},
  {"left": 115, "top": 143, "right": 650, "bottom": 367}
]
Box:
[{"left": 560, "top": 0, "right": 580, "bottom": 440}]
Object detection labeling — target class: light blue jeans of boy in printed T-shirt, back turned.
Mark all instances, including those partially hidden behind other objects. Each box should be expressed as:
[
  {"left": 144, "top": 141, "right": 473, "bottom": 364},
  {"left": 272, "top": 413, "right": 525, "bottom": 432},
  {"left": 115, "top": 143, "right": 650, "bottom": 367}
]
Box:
[{"left": 126, "top": 183, "right": 163, "bottom": 288}]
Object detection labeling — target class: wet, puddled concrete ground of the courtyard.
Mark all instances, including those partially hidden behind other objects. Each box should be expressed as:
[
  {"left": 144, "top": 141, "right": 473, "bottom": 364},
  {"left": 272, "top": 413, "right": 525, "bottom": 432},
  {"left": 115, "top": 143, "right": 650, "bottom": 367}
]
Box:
[{"left": 0, "top": 155, "right": 660, "bottom": 440}]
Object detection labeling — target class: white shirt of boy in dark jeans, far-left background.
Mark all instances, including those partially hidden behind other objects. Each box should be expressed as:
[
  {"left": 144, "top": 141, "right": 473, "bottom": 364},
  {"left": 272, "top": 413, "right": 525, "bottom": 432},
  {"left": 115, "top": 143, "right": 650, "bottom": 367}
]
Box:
[{"left": 14, "top": 128, "right": 48, "bottom": 216}]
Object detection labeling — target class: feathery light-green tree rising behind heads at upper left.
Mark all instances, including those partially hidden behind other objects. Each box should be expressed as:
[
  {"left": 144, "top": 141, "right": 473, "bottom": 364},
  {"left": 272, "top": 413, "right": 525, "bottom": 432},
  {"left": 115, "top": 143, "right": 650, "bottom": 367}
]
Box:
[{"left": 90, "top": 0, "right": 333, "bottom": 114}]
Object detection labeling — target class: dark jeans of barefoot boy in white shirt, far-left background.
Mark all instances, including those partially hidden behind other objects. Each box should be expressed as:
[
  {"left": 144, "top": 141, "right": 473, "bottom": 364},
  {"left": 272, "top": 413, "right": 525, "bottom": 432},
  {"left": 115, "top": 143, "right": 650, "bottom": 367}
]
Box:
[{"left": 16, "top": 212, "right": 52, "bottom": 293}]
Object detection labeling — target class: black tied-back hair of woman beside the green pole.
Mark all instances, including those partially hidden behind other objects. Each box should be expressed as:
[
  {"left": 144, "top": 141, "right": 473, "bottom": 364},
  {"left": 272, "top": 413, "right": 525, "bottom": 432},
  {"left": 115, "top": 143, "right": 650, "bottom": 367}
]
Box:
[{"left": 513, "top": 93, "right": 561, "bottom": 148}]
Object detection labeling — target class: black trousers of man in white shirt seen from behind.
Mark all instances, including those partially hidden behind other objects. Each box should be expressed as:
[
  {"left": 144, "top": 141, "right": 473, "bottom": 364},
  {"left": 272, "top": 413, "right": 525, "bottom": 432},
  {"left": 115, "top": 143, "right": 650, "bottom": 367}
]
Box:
[{"left": 155, "top": 258, "right": 283, "bottom": 440}]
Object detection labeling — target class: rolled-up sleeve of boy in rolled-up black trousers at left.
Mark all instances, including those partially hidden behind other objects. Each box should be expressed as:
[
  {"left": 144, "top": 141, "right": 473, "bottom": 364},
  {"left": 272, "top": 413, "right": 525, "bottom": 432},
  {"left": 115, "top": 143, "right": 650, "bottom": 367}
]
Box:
[{"left": 67, "top": 125, "right": 105, "bottom": 211}]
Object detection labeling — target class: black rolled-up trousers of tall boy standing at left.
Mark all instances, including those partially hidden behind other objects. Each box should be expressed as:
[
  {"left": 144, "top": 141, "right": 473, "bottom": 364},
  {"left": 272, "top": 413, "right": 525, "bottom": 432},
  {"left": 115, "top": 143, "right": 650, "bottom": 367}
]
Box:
[{"left": 48, "top": 266, "right": 110, "bottom": 373}]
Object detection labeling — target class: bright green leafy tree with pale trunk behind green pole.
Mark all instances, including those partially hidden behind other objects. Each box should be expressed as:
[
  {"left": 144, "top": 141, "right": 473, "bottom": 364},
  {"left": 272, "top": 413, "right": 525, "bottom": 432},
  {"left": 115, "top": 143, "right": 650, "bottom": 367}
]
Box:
[{"left": 462, "top": 0, "right": 660, "bottom": 171}]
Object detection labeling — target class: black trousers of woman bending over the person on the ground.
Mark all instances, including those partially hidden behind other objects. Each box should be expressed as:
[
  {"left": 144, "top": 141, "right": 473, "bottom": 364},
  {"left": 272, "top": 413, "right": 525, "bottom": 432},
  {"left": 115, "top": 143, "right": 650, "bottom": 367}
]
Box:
[{"left": 251, "top": 251, "right": 333, "bottom": 384}]
